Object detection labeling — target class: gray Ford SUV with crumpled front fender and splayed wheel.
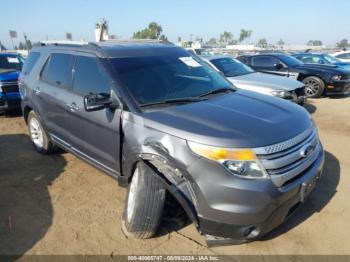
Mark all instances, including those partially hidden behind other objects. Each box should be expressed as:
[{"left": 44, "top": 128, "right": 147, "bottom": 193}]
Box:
[{"left": 20, "top": 41, "right": 324, "bottom": 243}]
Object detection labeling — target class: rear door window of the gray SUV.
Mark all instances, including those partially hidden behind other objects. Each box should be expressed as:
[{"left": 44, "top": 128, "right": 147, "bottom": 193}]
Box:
[{"left": 41, "top": 54, "right": 74, "bottom": 89}]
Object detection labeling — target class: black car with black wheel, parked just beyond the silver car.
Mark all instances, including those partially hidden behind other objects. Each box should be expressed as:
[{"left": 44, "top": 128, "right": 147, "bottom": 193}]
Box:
[{"left": 237, "top": 53, "right": 350, "bottom": 97}]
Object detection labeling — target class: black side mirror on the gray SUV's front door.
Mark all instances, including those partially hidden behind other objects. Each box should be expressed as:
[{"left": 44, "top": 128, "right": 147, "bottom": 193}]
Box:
[{"left": 84, "top": 93, "right": 118, "bottom": 112}]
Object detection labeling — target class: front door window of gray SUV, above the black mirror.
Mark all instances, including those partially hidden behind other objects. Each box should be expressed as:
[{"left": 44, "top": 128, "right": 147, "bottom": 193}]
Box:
[{"left": 73, "top": 56, "right": 111, "bottom": 96}]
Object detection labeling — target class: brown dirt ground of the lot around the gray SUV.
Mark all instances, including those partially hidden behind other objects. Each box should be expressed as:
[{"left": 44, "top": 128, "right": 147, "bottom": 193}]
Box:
[{"left": 0, "top": 97, "right": 350, "bottom": 255}]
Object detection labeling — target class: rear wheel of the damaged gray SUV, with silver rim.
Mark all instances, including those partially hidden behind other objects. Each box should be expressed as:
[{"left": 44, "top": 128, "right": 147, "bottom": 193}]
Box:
[{"left": 27, "top": 111, "right": 56, "bottom": 154}]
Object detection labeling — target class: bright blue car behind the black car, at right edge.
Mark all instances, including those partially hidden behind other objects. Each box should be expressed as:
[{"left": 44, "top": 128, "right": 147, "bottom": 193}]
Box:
[{"left": 292, "top": 53, "right": 350, "bottom": 70}]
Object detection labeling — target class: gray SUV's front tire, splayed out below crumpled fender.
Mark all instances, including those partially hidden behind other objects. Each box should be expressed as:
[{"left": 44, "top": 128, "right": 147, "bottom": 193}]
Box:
[{"left": 122, "top": 162, "right": 166, "bottom": 239}]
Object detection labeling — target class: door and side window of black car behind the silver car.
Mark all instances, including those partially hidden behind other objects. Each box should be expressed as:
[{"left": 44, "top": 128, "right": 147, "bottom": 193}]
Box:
[{"left": 251, "top": 55, "right": 289, "bottom": 77}]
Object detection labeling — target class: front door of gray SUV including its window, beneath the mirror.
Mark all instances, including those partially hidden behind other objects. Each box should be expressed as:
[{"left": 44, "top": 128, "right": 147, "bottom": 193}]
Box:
[{"left": 60, "top": 54, "right": 121, "bottom": 174}]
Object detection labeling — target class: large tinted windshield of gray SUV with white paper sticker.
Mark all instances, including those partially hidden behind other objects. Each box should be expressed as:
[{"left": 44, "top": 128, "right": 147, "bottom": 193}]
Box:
[{"left": 111, "top": 49, "right": 232, "bottom": 105}]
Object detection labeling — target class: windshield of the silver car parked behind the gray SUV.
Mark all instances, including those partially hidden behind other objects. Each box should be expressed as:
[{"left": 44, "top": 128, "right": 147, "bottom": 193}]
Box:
[{"left": 210, "top": 57, "right": 254, "bottom": 77}]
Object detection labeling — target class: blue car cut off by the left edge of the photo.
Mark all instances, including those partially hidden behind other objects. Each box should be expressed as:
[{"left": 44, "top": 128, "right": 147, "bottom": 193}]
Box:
[{"left": 0, "top": 53, "right": 24, "bottom": 112}]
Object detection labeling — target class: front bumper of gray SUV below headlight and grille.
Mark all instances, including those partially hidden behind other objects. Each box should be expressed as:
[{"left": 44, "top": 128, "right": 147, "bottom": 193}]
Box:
[{"left": 191, "top": 145, "right": 324, "bottom": 242}]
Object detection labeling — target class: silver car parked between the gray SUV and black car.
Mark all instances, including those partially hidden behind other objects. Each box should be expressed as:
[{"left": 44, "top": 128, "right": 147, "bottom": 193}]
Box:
[{"left": 201, "top": 55, "right": 305, "bottom": 104}]
